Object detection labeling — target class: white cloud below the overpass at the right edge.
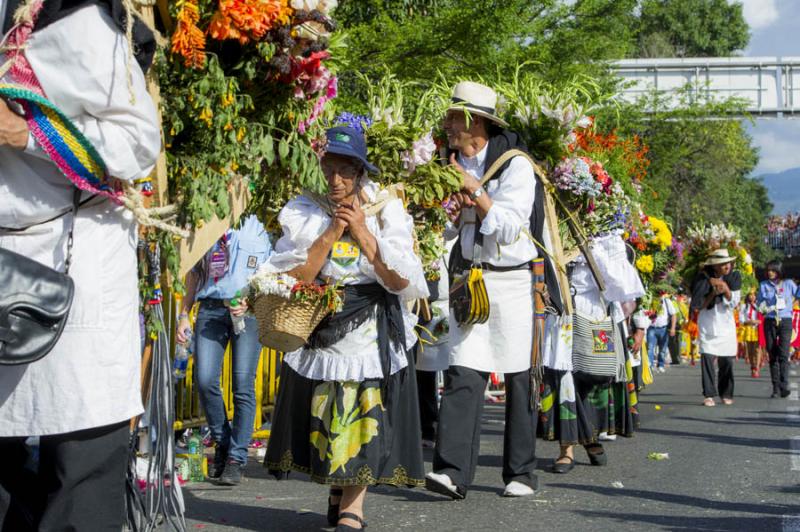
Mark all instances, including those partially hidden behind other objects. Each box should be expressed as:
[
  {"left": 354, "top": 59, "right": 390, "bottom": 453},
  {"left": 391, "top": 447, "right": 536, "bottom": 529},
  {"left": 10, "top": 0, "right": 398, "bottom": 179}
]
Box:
[{"left": 750, "top": 120, "right": 800, "bottom": 175}]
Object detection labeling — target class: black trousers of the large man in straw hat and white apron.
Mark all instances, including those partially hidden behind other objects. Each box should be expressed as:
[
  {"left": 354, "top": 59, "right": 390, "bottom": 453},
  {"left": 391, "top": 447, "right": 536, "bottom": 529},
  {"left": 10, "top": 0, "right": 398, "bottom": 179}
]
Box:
[{"left": 433, "top": 366, "right": 538, "bottom": 492}]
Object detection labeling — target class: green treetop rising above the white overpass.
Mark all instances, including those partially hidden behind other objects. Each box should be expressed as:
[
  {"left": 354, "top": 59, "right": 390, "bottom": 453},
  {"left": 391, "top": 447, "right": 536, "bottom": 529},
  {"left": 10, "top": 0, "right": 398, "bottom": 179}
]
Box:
[{"left": 636, "top": 0, "right": 750, "bottom": 57}]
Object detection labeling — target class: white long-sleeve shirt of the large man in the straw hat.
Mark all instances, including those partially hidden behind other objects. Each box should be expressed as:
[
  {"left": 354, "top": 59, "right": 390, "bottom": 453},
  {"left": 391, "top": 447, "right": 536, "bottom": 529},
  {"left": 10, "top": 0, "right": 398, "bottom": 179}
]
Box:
[{"left": 446, "top": 144, "right": 538, "bottom": 266}]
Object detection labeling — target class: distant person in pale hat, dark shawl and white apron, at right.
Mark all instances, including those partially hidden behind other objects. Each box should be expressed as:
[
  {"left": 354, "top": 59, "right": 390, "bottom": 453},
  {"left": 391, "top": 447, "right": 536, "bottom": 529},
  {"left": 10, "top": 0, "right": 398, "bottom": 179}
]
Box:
[{"left": 692, "top": 249, "right": 742, "bottom": 406}]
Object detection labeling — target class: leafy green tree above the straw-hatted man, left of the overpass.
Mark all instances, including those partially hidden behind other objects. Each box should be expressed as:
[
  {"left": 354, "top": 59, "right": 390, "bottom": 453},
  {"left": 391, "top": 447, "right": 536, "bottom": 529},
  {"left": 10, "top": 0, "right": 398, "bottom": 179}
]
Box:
[{"left": 336, "top": 0, "right": 637, "bottom": 86}]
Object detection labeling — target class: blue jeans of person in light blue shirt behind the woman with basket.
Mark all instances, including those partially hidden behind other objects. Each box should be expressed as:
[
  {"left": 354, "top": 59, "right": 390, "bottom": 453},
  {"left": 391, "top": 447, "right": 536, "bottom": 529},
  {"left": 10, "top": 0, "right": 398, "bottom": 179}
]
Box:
[{"left": 194, "top": 300, "right": 261, "bottom": 464}]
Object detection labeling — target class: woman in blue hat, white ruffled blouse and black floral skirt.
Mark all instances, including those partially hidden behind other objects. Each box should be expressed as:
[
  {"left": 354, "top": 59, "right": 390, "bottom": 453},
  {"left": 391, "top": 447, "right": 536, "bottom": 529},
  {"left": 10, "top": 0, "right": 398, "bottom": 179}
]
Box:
[{"left": 265, "top": 127, "right": 428, "bottom": 530}]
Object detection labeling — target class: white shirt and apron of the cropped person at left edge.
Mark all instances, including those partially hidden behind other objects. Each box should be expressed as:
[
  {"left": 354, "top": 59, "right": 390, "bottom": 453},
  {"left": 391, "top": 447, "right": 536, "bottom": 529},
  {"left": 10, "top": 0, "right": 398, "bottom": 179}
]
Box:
[{"left": 0, "top": 5, "right": 161, "bottom": 437}]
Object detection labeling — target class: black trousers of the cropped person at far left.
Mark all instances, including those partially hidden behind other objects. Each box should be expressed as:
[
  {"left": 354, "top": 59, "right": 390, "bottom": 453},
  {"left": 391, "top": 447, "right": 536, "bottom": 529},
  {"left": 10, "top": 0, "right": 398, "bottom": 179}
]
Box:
[{"left": 0, "top": 421, "right": 130, "bottom": 532}]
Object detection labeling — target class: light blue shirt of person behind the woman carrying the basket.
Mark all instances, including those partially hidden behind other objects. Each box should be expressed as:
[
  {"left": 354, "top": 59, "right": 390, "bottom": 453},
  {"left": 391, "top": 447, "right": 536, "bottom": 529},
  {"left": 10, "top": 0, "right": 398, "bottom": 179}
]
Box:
[{"left": 196, "top": 215, "right": 272, "bottom": 299}]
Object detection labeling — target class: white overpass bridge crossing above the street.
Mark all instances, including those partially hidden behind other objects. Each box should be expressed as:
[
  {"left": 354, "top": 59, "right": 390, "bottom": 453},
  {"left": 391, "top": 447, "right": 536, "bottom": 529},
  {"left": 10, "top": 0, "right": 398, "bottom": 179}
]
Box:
[{"left": 612, "top": 57, "right": 800, "bottom": 119}]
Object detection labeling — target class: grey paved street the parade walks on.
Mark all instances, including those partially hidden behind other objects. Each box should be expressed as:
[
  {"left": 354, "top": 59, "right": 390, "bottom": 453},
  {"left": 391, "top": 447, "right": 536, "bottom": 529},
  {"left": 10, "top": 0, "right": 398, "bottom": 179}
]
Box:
[{"left": 178, "top": 361, "right": 800, "bottom": 531}]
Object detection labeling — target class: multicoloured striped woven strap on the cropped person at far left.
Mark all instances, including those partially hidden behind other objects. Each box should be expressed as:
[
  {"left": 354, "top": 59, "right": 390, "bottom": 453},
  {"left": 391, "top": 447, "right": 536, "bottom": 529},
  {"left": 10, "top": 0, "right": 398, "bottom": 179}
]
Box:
[{"left": 0, "top": 84, "right": 120, "bottom": 200}]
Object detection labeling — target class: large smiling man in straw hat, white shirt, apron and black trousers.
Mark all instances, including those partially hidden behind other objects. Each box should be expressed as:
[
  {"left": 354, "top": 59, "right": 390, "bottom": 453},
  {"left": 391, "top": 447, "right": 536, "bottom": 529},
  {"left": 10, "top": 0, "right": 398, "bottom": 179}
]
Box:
[{"left": 426, "top": 81, "right": 561, "bottom": 499}]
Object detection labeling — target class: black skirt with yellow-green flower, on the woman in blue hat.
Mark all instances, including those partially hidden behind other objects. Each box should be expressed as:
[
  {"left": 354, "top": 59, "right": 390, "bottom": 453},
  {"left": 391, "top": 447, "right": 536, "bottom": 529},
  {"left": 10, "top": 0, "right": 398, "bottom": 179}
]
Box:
[{"left": 264, "top": 348, "right": 425, "bottom": 487}]
